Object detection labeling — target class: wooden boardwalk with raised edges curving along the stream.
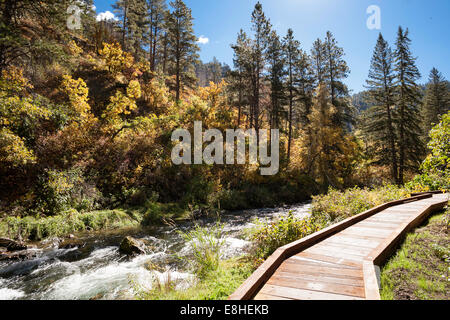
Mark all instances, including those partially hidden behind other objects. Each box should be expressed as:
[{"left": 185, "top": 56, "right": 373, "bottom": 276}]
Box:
[{"left": 229, "top": 193, "right": 448, "bottom": 300}]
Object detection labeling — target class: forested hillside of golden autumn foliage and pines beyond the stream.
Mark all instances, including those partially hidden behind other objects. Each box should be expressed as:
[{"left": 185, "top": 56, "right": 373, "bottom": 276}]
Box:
[{"left": 0, "top": 0, "right": 450, "bottom": 225}]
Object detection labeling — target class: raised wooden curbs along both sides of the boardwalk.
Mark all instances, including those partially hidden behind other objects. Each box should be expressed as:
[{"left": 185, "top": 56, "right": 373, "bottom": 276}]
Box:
[{"left": 229, "top": 193, "right": 444, "bottom": 300}]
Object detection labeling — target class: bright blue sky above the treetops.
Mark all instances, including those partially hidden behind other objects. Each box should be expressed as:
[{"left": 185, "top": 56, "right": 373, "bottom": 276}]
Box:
[{"left": 94, "top": 0, "right": 450, "bottom": 92}]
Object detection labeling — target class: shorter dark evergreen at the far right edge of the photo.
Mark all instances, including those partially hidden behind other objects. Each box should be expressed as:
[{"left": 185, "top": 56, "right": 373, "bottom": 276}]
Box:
[{"left": 423, "top": 68, "right": 450, "bottom": 135}]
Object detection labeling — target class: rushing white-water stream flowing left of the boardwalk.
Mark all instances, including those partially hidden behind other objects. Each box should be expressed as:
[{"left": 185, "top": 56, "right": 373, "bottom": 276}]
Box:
[{"left": 0, "top": 204, "right": 310, "bottom": 300}]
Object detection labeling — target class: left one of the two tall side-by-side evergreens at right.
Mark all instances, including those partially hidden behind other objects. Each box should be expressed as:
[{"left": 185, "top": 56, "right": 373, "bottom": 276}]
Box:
[{"left": 363, "top": 33, "right": 399, "bottom": 183}]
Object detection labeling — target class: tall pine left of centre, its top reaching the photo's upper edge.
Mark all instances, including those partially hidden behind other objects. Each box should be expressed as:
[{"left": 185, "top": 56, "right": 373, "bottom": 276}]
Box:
[{"left": 167, "top": 0, "right": 199, "bottom": 101}]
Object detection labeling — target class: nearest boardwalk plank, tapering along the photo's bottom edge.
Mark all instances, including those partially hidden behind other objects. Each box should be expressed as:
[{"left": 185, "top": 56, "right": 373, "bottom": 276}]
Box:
[{"left": 261, "top": 284, "right": 363, "bottom": 300}]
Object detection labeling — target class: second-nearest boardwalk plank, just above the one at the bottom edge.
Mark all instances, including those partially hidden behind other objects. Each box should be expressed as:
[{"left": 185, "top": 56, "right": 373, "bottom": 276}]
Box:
[{"left": 267, "top": 273, "right": 365, "bottom": 298}]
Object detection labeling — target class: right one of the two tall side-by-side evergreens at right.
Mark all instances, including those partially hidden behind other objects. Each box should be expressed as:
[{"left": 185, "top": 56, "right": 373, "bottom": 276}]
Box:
[{"left": 394, "top": 27, "right": 425, "bottom": 184}]
